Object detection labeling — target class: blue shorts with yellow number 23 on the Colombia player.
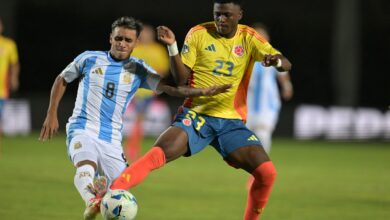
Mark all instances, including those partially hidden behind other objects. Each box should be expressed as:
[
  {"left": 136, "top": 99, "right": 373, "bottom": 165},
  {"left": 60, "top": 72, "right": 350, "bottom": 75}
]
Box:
[{"left": 173, "top": 108, "right": 261, "bottom": 158}]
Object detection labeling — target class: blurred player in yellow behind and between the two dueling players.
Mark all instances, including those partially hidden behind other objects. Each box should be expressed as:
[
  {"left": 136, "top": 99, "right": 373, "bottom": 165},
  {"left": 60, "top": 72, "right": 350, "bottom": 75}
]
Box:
[{"left": 125, "top": 25, "right": 169, "bottom": 161}]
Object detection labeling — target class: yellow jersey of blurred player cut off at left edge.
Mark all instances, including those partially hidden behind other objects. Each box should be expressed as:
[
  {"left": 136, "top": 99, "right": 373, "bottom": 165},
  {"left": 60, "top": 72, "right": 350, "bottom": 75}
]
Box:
[{"left": 0, "top": 36, "right": 18, "bottom": 99}]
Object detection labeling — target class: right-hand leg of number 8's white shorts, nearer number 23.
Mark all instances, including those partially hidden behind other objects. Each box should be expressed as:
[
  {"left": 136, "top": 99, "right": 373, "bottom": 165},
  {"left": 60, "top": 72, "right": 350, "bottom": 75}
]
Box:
[{"left": 97, "top": 140, "right": 127, "bottom": 182}]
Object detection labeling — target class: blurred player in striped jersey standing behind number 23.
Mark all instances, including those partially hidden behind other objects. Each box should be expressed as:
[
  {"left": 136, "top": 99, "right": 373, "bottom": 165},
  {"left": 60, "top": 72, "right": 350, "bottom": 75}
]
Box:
[{"left": 247, "top": 23, "right": 293, "bottom": 153}]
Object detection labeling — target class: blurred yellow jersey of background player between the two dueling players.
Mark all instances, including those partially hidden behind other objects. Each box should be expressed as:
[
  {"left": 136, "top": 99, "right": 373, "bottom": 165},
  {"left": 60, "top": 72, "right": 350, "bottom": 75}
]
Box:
[{"left": 131, "top": 43, "right": 169, "bottom": 98}]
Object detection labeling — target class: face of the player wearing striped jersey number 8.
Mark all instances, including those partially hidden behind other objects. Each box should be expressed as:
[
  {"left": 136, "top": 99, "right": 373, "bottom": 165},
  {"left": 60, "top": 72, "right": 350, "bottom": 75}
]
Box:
[{"left": 110, "top": 27, "right": 138, "bottom": 60}]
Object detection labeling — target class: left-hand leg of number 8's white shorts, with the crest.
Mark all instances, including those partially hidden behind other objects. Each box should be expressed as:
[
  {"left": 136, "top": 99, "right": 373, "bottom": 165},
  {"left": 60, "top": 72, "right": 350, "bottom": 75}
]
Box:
[{"left": 68, "top": 134, "right": 99, "bottom": 166}]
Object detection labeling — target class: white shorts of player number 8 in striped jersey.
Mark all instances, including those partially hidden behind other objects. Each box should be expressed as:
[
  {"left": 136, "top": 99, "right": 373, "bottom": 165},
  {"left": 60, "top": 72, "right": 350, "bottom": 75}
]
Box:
[{"left": 68, "top": 134, "right": 127, "bottom": 183}]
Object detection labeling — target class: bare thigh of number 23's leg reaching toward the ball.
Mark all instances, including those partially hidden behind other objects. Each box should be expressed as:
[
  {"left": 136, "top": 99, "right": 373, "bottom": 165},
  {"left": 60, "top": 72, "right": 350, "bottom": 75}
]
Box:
[{"left": 155, "top": 126, "right": 188, "bottom": 162}]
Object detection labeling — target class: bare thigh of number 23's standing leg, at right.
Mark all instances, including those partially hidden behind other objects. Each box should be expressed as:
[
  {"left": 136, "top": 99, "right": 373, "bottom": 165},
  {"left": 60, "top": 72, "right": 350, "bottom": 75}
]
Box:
[{"left": 224, "top": 145, "right": 270, "bottom": 173}]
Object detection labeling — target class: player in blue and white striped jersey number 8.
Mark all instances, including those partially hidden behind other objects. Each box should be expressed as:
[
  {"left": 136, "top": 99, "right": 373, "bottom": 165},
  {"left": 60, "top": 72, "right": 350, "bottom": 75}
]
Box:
[{"left": 39, "top": 17, "right": 230, "bottom": 219}]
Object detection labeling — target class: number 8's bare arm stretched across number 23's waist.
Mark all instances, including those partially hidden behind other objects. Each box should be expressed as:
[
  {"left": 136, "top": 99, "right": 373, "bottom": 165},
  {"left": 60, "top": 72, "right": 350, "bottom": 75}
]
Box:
[{"left": 157, "top": 83, "right": 232, "bottom": 97}]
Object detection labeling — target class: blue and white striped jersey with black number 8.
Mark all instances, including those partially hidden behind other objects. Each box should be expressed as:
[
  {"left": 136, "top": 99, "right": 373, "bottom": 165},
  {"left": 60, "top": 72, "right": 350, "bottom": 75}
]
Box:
[{"left": 61, "top": 51, "right": 160, "bottom": 145}]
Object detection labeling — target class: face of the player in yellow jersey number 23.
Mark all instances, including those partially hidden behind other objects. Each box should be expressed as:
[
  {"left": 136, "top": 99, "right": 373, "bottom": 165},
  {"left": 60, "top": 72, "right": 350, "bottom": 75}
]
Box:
[{"left": 214, "top": 3, "right": 242, "bottom": 38}]
